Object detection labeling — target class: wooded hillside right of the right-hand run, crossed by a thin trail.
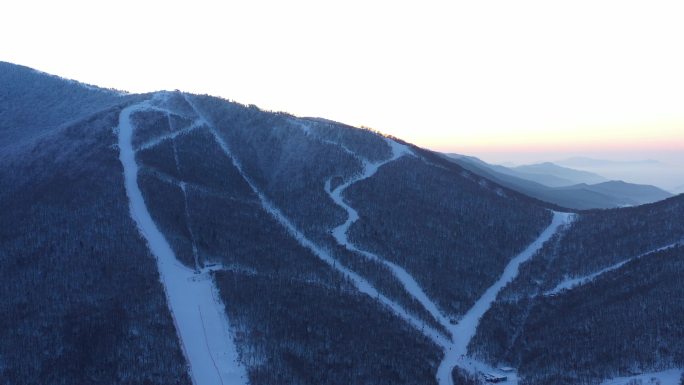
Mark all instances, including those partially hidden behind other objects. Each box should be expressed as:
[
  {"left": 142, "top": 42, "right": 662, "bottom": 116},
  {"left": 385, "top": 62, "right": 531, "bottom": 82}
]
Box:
[{"left": 471, "top": 196, "right": 684, "bottom": 384}]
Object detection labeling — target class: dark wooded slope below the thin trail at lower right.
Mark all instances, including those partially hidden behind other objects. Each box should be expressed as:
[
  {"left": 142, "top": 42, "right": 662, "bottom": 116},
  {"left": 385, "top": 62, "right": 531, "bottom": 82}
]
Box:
[{"left": 514, "top": 247, "right": 684, "bottom": 384}]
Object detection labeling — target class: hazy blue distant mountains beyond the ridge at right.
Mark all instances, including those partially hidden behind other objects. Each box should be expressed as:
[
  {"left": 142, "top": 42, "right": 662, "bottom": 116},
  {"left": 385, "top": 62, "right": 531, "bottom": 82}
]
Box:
[{"left": 448, "top": 154, "right": 672, "bottom": 210}]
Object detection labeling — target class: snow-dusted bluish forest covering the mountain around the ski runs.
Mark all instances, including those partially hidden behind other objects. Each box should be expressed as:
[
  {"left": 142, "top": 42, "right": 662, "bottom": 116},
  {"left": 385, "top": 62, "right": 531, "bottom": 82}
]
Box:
[{"left": 0, "top": 59, "right": 684, "bottom": 384}]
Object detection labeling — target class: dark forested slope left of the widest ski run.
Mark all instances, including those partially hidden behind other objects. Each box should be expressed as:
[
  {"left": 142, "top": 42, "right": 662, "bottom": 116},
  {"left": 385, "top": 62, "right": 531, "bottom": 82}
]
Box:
[{"left": 0, "top": 102, "right": 190, "bottom": 385}]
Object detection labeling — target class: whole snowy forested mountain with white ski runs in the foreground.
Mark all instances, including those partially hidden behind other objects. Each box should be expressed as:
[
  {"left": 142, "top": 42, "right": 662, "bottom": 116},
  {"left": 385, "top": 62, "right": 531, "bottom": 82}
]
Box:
[{"left": 0, "top": 64, "right": 684, "bottom": 385}]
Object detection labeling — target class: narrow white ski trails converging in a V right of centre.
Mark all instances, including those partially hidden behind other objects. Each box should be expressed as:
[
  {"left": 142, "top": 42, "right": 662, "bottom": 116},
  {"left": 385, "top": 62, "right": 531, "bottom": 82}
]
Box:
[{"left": 179, "top": 94, "right": 573, "bottom": 385}]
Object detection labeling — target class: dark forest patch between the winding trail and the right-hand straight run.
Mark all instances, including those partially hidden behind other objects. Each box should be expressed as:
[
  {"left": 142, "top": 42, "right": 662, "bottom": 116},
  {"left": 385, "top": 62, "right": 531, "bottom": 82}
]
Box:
[{"left": 348, "top": 157, "right": 550, "bottom": 316}]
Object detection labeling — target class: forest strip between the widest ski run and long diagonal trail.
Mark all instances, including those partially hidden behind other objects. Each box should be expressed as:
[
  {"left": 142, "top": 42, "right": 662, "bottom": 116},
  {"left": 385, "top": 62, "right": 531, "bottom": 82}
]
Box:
[{"left": 131, "top": 94, "right": 446, "bottom": 384}]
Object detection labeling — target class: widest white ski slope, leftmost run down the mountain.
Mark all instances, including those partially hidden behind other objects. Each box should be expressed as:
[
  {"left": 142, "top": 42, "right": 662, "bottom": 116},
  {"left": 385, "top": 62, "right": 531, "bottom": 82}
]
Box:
[{"left": 118, "top": 102, "right": 248, "bottom": 385}]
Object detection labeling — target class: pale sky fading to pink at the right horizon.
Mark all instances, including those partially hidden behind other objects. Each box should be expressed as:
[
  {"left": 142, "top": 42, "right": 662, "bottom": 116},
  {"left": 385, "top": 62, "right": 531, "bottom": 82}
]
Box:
[{"left": 0, "top": 0, "right": 684, "bottom": 165}]
